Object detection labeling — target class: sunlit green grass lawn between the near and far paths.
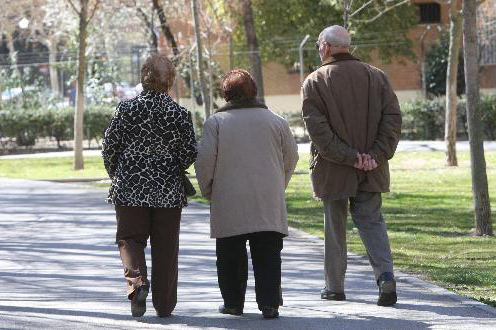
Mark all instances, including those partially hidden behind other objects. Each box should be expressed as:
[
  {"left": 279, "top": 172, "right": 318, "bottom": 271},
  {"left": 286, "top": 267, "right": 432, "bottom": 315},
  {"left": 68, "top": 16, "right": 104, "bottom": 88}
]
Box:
[{"left": 0, "top": 152, "right": 496, "bottom": 306}]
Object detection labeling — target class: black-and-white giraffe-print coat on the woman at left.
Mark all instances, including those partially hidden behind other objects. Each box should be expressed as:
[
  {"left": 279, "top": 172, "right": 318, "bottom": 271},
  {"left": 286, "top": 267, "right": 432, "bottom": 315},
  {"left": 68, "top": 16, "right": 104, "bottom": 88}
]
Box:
[{"left": 102, "top": 90, "right": 197, "bottom": 208}]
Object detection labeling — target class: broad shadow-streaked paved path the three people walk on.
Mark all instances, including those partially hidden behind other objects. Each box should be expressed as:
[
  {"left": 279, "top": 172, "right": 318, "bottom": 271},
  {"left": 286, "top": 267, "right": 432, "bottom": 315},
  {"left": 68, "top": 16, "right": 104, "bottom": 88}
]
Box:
[{"left": 0, "top": 179, "right": 496, "bottom": 330}]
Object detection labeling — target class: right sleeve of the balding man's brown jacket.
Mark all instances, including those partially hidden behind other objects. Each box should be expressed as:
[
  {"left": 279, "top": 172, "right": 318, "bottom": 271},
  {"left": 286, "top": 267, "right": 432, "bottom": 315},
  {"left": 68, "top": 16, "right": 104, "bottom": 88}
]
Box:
[{"left": 369, "top": 75, "right": 401, "bottom": 164}]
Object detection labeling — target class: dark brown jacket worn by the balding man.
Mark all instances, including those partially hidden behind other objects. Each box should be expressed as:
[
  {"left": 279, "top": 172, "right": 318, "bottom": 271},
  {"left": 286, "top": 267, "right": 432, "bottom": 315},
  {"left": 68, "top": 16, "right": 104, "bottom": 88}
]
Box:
[{"left": 301, "top": 53, "right": 401, "bottom": 200}]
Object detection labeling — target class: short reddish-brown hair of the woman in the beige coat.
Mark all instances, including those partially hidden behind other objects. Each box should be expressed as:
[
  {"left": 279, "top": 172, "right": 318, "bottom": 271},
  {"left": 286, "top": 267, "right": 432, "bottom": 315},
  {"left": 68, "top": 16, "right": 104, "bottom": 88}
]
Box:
[{"left": 220, "top": 69, "right": 257, "bottom": 102}]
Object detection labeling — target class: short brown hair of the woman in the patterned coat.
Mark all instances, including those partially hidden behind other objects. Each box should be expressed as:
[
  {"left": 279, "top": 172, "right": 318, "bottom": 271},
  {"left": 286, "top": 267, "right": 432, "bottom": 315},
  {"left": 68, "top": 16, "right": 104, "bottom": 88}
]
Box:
[{"left": 141, "top": 54, "right": 176, "bottom": 93}]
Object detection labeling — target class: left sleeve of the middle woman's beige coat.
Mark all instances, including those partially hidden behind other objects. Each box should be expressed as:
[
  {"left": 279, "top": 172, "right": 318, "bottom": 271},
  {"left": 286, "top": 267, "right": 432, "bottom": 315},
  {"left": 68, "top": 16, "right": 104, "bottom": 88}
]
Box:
[{"left": 195, "top": 117, "right": 219, "bottom": 200}]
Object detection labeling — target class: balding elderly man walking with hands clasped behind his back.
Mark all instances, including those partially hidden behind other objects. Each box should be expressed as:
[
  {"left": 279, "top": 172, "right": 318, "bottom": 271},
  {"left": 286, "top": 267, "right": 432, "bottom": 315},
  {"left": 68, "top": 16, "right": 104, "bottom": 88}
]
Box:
[{"left": 301, "top": 25, "right": 401, "bottom": 306}]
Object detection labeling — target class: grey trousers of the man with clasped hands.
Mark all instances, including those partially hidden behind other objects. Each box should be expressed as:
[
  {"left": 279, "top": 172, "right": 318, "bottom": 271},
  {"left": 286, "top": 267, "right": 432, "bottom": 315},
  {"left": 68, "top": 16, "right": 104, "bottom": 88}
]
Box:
[{"left": 324, "top": 191, "right": 393, "bottom": 292}]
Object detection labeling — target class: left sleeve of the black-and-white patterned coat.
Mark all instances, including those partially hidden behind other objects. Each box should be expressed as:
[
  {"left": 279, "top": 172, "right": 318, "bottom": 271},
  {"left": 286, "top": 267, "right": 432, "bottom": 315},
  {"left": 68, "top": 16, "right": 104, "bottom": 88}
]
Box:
[{"left": 102, "top": 102, "right": 125, "bottom": 179}]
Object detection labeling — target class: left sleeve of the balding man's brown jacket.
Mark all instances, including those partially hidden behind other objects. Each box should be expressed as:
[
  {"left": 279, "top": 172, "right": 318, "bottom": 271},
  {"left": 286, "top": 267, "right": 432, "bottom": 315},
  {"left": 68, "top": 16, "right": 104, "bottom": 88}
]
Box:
[{"left": 301, "top": 79, "right": 358, "bottom": 166}]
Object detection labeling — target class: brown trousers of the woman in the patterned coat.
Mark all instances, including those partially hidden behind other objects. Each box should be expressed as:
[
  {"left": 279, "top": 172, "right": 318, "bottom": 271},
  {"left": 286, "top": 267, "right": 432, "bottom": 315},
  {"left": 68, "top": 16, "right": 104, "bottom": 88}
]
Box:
[{"left": 115, "top": 206, "right": 182, "bottom": 315}]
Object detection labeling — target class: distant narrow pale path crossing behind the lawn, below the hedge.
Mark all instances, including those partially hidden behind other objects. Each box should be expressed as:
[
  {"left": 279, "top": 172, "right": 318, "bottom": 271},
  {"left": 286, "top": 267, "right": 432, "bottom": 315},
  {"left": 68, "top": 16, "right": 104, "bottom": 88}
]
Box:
[{"left": 0, "top": 141, "right": 496, "bottom": 160}]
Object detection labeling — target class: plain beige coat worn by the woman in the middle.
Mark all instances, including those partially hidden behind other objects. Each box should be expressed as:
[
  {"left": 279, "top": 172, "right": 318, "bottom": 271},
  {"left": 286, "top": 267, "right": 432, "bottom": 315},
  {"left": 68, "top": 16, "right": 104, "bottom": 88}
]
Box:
[{"left": 195, "top": 102, "right": 298, "bottom": 238}]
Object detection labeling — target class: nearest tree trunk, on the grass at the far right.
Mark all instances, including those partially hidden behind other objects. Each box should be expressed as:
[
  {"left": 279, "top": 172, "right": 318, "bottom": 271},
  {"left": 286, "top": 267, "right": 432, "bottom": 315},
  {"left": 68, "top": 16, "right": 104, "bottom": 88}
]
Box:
[{"left": 463, "top": 1, "right": 493, "bottom": 236}]
